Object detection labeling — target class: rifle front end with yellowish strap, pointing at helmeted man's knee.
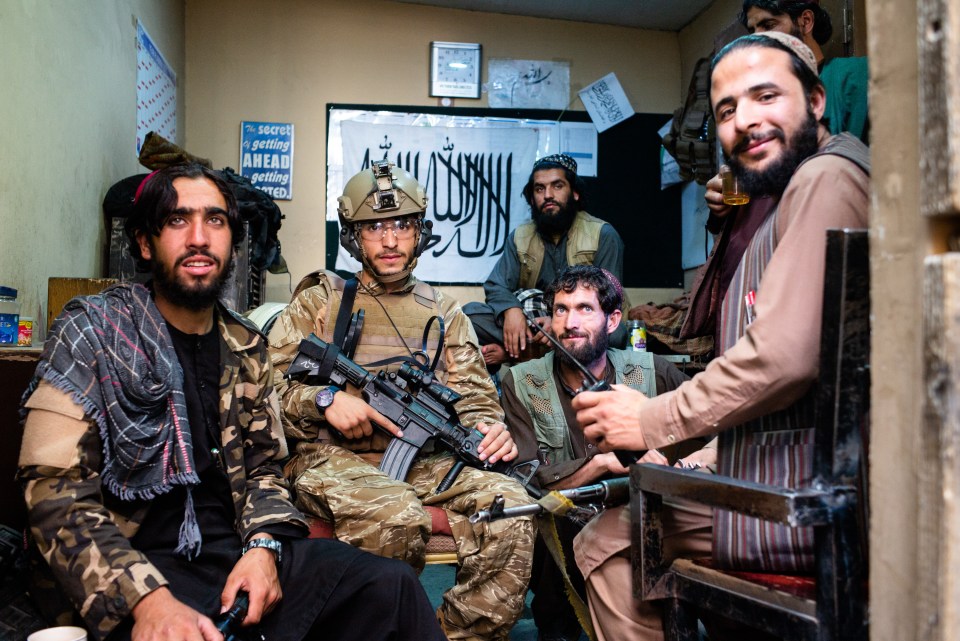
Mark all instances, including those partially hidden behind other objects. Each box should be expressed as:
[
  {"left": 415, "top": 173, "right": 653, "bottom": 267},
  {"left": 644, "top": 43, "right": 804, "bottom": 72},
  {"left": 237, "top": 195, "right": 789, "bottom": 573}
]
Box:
[{"left": 470, "top": 476, "right": 630, "bottom": 523}]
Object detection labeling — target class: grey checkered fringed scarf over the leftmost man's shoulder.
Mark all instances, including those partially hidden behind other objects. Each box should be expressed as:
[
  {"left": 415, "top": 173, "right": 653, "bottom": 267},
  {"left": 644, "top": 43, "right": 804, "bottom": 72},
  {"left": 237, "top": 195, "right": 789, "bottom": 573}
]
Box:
[{"left": 23, "top": 284, "right": 200, "bottom": 557}]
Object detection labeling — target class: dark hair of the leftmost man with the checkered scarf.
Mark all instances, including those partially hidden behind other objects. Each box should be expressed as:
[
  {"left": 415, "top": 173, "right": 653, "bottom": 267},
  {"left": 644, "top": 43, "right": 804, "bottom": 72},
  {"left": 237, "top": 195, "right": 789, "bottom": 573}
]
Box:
[{"left": 123, "top": 163, "right": 244, "bottom": 271}]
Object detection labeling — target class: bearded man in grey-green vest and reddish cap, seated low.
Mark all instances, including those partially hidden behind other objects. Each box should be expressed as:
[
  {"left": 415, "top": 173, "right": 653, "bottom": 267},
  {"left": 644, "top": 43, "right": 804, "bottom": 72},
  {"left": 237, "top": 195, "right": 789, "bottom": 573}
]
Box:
[{"left": 502, "top": 265, "right": 688, "bottom": 641}]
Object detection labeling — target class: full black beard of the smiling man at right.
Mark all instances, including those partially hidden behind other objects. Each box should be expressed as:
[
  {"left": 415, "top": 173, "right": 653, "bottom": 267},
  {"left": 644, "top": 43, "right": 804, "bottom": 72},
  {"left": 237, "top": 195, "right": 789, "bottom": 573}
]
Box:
[{"left": 727, "top": 108, "right": 819, "bottom": 196}]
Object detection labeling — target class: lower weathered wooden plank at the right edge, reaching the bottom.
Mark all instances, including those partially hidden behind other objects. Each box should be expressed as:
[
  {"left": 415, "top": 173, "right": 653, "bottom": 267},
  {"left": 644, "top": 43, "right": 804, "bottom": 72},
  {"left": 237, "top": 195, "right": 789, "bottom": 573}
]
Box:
[{"left": 918, "top": 253, "right": 960, "bottom": 640}]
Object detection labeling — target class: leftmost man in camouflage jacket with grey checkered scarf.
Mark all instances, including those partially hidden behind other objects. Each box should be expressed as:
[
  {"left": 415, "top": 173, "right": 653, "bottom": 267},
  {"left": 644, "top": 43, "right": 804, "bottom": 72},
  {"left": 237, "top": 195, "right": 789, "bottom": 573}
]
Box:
[{"left": 18, "top": 165, "right": 443, "bottom": 641}]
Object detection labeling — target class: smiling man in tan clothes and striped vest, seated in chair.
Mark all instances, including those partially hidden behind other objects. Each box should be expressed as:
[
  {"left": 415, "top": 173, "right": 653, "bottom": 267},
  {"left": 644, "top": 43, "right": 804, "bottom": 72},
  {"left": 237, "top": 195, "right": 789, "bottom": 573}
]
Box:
[{"left": 573, "top": 32, "right": 869, "bottom": 639}]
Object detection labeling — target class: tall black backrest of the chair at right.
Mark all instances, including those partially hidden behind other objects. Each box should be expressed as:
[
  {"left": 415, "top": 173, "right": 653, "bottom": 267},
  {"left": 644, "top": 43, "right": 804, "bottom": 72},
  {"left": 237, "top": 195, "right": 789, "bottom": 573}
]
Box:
[{"left": 813, "top": 229, "right": 870, "bottom": 640}]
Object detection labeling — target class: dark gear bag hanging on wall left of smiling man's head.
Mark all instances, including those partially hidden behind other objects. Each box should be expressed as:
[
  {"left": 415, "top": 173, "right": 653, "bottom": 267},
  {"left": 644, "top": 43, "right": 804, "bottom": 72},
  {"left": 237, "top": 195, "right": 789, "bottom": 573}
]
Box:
[{"left": 663, "top": 58, "right": 717, "bottom": 185}]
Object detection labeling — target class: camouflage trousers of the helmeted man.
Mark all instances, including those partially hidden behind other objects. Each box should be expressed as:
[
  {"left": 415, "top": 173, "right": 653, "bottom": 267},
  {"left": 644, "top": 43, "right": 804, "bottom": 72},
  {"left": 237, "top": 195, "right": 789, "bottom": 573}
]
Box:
[{"left": 286, "top": 443, "right": 536, "bottom": 640}]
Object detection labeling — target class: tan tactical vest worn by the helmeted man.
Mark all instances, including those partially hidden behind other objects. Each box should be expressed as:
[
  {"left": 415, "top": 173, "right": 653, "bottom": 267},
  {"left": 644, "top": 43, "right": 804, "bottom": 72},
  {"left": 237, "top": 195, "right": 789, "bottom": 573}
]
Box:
[{"left": 294, "top": 270, "right": 447, "bottom": 458}]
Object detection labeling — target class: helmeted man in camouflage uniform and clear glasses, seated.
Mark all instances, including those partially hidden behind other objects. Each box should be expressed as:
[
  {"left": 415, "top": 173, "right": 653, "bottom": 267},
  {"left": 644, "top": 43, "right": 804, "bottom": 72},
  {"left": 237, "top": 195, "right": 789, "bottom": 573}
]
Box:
[{"left": 270, "top": 161, "right": 534, "bottom": 639}]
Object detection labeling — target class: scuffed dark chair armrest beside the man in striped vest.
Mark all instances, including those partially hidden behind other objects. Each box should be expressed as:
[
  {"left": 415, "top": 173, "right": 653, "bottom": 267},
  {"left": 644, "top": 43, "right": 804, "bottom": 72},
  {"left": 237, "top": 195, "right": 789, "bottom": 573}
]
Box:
[{"left": 630, "top": 463, "right": 855, "bottom": 527}]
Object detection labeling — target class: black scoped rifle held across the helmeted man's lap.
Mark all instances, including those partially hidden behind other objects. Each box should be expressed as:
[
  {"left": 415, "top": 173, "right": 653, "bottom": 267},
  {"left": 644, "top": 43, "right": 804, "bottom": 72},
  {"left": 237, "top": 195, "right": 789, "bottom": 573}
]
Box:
[{"left": 286, "top": 334, "right": 539, "bottom": 494}]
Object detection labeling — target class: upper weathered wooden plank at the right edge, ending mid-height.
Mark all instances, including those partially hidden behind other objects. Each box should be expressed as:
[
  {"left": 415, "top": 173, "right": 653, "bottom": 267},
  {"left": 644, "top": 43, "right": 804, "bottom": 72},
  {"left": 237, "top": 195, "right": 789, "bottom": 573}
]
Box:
[{"left": 917, "top": 0, "right": 960, "bottom": 216}]
